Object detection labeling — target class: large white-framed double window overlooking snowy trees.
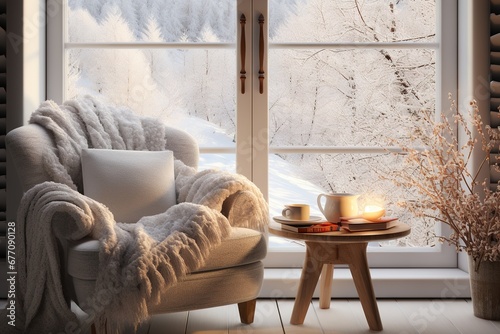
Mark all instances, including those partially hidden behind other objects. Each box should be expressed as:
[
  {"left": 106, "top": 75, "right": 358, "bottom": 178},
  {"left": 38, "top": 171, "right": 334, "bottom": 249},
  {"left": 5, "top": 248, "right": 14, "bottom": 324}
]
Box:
[{"left": 48, "top": 0, "right": 457, "bottom": 266}]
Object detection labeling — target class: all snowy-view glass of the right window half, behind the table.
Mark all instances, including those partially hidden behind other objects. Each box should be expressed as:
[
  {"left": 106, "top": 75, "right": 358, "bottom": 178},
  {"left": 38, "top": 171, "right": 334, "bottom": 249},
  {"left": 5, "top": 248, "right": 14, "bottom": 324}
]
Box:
[{"left": 268, "top": 0, "right": 440, "bottom": 252}]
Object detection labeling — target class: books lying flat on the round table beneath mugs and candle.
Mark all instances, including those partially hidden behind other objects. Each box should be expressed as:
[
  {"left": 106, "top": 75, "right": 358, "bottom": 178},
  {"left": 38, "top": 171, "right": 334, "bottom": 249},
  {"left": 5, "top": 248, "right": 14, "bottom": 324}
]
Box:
[{"left": 281, "top": 217, "right": 398, "bottom": 233}]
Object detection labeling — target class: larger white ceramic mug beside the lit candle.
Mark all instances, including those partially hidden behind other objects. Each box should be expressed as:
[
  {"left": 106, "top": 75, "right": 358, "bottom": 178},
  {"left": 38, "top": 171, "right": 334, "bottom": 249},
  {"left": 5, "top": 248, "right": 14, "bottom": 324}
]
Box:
[{"left": 318, "top": 193, "right": 359, "bottom": 223}]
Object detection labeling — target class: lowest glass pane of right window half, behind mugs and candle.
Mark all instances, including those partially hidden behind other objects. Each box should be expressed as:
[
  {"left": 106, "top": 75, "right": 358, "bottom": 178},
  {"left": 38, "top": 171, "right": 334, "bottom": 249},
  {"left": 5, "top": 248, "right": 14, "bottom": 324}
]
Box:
[{"left": 269, "top": 154, "right": 435, "bottom": 247}]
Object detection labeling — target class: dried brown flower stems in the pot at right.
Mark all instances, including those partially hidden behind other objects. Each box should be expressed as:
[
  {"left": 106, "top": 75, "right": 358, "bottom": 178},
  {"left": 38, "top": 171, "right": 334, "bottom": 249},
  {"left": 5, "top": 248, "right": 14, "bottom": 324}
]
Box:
[{"left": 386, "top": 96, "right": 500, "bottom": 265}]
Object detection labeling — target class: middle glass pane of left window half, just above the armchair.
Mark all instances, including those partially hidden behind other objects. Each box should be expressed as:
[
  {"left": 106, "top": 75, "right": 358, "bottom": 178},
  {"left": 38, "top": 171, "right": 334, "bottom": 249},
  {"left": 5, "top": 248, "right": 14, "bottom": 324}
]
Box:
[{"left": 66, "top": 48, "right": 236, "bottom": 147}]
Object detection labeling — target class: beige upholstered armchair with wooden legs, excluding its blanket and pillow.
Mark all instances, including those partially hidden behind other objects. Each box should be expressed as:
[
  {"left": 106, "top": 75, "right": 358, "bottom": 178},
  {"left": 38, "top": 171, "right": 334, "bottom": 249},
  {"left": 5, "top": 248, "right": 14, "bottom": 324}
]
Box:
[{"left": 6, "top": 101, "right": 267, "bottom": 330}]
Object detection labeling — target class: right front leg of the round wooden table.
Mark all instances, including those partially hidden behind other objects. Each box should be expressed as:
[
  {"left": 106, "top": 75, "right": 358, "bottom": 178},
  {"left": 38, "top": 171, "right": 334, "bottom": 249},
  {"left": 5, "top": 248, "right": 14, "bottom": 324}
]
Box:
[{"left": 343, "top": 244, "right": 383, "bottom": 331}]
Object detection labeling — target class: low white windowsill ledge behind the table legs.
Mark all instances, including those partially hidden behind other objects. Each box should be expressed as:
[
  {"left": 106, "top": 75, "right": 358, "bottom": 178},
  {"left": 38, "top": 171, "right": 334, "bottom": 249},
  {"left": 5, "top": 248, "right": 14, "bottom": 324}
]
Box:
[{"left": 260, "top": 268, "right": 470, "bottom": 299}]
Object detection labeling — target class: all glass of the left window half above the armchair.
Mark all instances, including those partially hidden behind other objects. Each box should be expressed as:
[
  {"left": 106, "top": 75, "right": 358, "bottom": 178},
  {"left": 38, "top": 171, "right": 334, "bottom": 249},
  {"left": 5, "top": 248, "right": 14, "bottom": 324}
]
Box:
[{"left": 65, "top": 0, "right": 237, "bottom": 153}]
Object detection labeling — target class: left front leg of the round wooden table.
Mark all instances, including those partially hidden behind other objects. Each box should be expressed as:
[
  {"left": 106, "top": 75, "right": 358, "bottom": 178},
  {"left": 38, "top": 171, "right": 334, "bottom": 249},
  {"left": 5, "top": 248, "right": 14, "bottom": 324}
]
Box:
[{"left": 290, "top": 243, "right": 323, "bottom": 325}]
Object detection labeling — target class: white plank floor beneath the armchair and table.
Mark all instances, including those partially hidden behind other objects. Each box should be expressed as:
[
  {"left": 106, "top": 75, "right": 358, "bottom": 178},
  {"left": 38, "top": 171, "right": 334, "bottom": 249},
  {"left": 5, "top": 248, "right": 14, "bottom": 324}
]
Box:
[{"left": 0, "top": 299, "right": 500, "bottom": 334}]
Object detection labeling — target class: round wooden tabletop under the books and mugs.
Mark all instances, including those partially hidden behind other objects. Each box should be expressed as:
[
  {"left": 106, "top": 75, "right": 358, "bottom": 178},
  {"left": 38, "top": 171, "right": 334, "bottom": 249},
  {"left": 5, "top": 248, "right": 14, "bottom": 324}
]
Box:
[{"left": 269, "top": 221, "right": 411, "bottom": 243}]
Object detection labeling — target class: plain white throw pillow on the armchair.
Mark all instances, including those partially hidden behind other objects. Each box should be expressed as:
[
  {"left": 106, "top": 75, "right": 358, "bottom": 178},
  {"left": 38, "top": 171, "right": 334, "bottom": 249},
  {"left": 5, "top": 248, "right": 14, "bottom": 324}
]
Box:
[{"left": 82, "top": 149, "right": 176, "bottom": 223}]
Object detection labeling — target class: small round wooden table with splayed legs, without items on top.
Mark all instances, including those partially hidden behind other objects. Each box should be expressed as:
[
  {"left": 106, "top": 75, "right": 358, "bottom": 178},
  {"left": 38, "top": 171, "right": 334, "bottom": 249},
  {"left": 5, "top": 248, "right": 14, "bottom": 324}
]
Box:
[{"left": 269, "top": 222, "right": 410, "bottom": 331}]
